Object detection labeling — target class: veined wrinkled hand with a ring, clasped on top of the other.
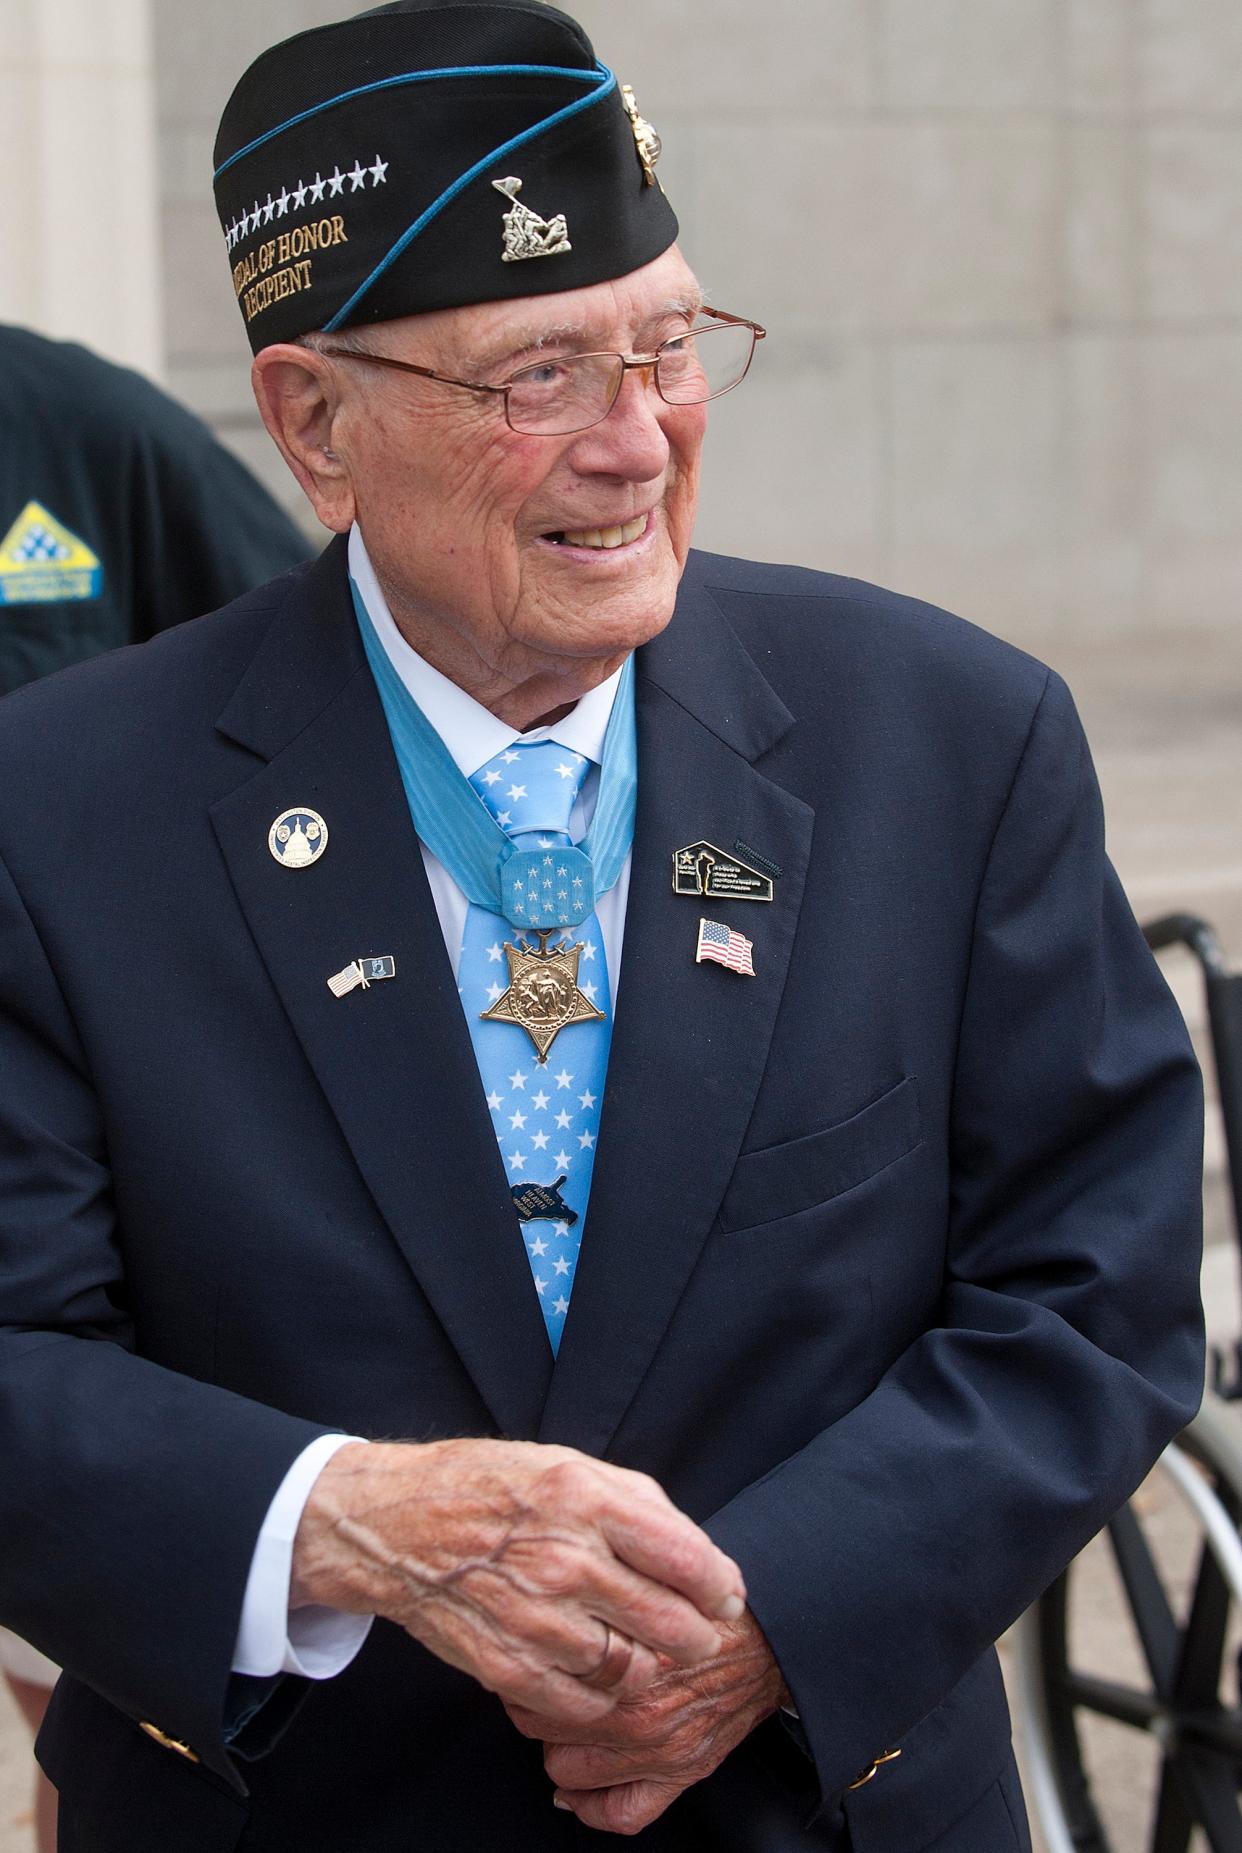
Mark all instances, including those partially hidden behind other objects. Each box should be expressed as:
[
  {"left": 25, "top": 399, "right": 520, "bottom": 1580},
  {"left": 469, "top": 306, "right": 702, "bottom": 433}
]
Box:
[{"left": 291, "top": 1440, "right": 745, "bottom": 1723}]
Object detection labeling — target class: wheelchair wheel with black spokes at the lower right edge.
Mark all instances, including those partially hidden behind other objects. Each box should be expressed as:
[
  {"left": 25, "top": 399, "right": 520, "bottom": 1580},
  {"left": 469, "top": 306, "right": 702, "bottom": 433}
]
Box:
[{"left": 1014, "top": 1397, "right": 1242, "bottom": 1853}]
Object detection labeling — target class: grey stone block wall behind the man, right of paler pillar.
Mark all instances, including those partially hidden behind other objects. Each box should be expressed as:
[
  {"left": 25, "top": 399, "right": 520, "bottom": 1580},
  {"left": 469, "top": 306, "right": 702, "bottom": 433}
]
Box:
[{"left": 152, "top": 0, "right": 1242, "bottom": 649}]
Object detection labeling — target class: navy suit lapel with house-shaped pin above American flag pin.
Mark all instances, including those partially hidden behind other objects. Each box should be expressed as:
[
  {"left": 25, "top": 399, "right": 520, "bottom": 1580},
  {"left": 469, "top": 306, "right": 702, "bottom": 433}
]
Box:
[{"left": 539, "top": 570, "right": 814, "bottom": 1455}]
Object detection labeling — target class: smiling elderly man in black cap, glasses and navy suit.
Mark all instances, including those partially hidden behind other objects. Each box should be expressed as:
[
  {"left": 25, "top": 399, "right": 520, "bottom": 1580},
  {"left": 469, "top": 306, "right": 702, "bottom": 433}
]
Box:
[{"left": 0, "top": 0, "right": 1201, "bottom": 1853}]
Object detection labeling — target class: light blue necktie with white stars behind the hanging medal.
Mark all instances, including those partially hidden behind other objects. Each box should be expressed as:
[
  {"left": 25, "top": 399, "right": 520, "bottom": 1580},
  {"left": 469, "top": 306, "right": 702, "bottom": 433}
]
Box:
[{"left": 458, "top": 739, "right": 612, "bottom": 1355}]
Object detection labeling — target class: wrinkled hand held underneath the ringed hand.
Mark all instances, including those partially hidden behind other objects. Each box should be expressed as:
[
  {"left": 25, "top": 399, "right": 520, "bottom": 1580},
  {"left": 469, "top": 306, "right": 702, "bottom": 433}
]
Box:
[{"left": 506, "top": 1612, "right": 790, "bottom": 1834}]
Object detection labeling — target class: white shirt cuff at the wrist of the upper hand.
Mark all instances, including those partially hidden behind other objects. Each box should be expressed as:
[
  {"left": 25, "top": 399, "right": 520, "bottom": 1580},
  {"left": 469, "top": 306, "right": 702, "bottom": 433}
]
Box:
[{"left": 234, "top": 1434, "right": 373, "bottom": 1679}]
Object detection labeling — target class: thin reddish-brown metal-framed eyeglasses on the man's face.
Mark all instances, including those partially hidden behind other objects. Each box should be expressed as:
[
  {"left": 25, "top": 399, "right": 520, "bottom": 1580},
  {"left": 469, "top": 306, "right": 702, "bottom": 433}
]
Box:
[{"left": 315, "top": 308, "right": 767, "bottom": 437}]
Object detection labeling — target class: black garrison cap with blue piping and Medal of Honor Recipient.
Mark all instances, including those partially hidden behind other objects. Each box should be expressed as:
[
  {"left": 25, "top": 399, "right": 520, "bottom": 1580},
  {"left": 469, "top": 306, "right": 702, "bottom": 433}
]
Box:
[{"left": 215, "top": 0, "right": 677, "bottom": 352}]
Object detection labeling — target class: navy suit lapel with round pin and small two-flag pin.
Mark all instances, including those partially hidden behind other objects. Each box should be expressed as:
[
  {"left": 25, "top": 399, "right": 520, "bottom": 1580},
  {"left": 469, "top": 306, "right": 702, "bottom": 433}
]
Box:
[{"left": 211, "top": 547, "right": 551, "bottom": 1436}]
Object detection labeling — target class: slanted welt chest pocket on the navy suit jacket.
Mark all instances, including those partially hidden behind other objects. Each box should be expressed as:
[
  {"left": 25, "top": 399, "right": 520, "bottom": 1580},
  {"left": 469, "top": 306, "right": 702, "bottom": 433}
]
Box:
[{"left": 716, "top": 1077, "right": 923, "bottom": 1234}]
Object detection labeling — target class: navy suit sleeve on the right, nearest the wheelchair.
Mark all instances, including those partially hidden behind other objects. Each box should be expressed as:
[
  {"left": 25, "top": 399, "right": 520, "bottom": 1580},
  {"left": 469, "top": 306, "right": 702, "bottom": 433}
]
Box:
[{"left": 708, "top": 676, "right": 1203, "bottom": 1796}]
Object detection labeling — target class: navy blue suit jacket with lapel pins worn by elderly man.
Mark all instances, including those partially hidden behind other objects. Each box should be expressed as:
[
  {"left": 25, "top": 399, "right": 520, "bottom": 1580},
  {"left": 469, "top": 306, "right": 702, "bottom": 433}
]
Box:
[{"left": 0, "top": 545, "right": 1201, "bottom": 1853}]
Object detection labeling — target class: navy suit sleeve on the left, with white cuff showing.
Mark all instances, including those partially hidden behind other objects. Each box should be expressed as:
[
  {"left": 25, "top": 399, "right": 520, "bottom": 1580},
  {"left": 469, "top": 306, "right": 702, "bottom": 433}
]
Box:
[{"left": 0, "top": 848, "right": 335, "bottom": 1783}]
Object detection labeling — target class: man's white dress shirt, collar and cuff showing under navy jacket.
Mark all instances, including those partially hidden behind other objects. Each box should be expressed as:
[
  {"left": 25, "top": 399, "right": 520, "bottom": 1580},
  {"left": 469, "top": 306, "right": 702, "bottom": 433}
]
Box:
[{"left": 234, "top": 526, "right": 630, "bottom": 1679}]
